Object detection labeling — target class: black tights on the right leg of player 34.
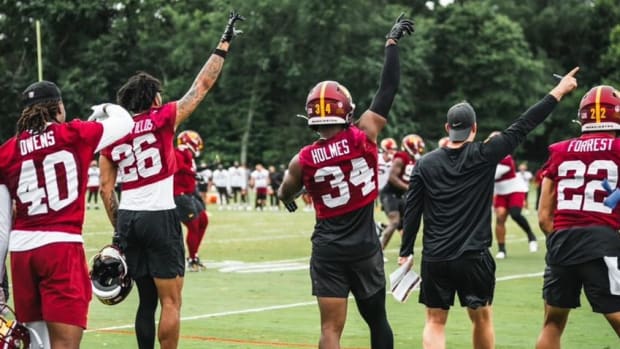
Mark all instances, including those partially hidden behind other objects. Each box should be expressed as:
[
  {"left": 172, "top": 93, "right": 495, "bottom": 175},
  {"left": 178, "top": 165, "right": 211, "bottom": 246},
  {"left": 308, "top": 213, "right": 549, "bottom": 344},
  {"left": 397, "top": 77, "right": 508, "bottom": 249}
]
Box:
[{"left": 355, "top": 288, "right": 394, "bottom": 349}]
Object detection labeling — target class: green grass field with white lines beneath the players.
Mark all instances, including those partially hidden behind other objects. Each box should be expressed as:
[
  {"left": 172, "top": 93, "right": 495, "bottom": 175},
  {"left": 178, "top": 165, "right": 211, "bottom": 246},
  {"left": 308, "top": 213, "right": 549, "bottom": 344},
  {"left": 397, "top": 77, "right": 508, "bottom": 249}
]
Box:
[{"left": 59, "top": 198, "right": 620, "bottom": 349}]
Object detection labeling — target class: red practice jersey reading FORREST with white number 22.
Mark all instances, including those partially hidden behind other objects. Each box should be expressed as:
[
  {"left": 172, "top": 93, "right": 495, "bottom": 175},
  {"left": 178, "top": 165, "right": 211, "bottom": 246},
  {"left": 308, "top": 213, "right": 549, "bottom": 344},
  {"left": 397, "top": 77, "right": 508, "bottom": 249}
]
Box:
[{"left": 543, "top": 133, "right": 620, "bottom": 231}]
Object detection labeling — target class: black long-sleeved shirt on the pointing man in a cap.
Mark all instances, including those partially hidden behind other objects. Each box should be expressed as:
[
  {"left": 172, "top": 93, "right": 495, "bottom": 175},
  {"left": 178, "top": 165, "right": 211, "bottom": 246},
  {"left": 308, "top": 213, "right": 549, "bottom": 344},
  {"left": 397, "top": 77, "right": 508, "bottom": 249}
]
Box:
[{"left": 400, "top": 95, "right": 557, "bottom": 262}]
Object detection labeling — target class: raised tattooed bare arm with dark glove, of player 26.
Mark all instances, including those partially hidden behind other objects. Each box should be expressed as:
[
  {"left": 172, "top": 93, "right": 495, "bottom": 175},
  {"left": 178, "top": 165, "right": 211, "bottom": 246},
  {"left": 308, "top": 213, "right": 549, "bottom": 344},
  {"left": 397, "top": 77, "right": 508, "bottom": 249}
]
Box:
[{"left": 175, "top": 12, "right": 245, "bottom": 128}]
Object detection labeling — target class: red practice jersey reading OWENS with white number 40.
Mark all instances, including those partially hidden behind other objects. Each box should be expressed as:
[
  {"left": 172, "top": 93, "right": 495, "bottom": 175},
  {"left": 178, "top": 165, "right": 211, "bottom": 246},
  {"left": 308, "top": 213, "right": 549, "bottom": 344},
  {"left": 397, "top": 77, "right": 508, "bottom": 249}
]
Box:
[{"left": 0, "top": 120, "right": 103, "bottom": 235}]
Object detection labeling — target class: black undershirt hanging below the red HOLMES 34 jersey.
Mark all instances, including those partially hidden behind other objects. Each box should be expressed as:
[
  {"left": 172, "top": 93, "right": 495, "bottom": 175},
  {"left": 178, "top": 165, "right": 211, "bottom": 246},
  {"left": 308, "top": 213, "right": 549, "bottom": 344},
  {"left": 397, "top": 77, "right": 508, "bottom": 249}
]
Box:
[{"left": 312, "top": 203, "right": 381, "bottom": 261}]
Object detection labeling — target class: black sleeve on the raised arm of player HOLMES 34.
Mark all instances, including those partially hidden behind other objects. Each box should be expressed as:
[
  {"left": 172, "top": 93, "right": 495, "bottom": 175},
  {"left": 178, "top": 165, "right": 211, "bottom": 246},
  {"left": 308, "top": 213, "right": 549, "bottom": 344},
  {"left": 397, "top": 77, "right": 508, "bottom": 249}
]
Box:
[{"left": 369, "top": 45, "right": 400, "bottom": 118}]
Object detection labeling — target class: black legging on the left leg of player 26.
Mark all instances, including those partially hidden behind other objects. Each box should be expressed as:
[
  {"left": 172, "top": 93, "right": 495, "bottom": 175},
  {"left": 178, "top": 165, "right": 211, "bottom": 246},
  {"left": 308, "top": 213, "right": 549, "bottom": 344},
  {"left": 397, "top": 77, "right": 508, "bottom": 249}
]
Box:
[{"left": 135, "top": 277, "right": 158, "bottom": 349}]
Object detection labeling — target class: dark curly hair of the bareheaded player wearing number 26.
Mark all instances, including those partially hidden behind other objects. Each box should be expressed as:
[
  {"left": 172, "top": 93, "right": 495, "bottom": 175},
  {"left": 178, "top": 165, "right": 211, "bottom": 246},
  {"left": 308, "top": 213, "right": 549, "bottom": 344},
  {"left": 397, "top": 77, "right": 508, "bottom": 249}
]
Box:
[{"left": 116, "top": 72, "right": 161, "bottom": 114}]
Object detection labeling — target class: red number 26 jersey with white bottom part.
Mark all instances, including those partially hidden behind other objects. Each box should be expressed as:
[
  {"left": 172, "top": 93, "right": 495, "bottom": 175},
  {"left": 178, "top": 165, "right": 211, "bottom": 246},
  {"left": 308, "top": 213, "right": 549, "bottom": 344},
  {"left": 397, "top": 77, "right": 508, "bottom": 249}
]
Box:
[{"left": 101, "top": 101, "right": 177, "bottom": 211}]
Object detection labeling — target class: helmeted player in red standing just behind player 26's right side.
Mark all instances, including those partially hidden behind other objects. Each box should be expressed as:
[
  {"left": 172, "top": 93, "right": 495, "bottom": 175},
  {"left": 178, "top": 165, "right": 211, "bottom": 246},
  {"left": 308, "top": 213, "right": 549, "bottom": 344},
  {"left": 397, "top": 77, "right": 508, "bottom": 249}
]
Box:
[{"left": 174, "top": 130, "right": 209, "bottom": 271}]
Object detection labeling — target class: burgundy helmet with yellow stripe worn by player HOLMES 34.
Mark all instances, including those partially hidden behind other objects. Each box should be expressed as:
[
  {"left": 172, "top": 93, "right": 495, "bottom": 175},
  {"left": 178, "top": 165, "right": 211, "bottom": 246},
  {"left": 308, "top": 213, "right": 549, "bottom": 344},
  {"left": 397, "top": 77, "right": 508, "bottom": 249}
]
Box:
[{"left": 306, "top": 80, "right": 355, "bottom": 126}]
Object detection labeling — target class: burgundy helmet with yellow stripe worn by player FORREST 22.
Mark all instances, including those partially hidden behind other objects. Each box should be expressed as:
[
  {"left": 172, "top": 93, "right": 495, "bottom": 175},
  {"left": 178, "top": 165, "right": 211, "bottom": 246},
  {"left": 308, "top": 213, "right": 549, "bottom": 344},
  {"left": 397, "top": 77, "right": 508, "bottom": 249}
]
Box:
[{"left": 578, "top": 85, "right": 620, "bottom": 132}]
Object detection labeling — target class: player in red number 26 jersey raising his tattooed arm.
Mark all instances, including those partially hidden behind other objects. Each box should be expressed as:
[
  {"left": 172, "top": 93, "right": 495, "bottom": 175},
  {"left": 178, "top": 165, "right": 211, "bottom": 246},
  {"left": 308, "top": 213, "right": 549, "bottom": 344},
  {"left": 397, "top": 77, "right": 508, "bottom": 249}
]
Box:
[{"left": 99, "top": 12, "right": 243, "bottom": 348}]
